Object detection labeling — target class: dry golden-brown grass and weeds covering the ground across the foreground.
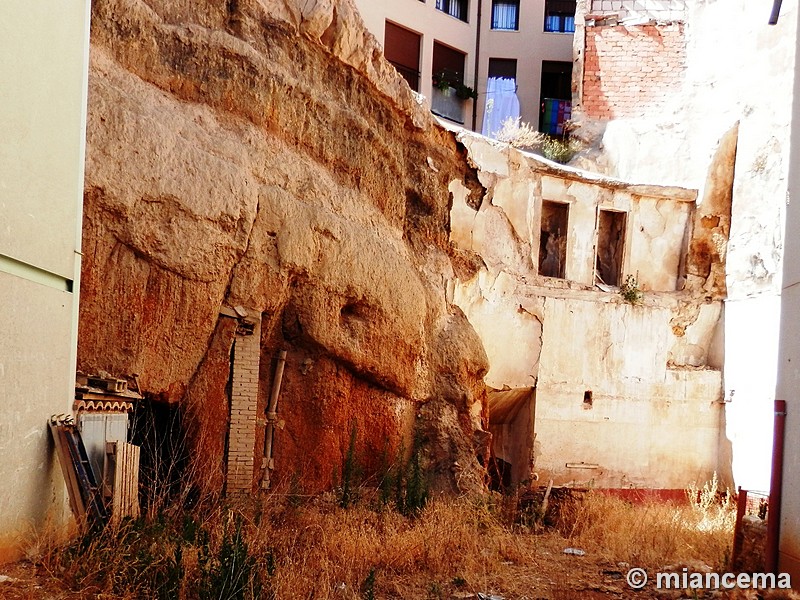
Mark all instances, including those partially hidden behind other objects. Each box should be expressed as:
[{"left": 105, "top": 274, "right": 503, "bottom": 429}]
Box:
[{"left": 17, "top": 480, "right": 744, "bottom": 600}]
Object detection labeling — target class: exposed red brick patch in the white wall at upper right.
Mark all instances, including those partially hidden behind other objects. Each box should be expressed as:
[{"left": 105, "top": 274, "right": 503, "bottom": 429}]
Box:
[{"left": 582, "top": 23, "right": 686, "bottom": 119}]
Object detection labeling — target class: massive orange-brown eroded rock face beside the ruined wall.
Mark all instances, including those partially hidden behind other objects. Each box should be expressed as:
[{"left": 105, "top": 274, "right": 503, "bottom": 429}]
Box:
[{"left": 78, "top": 0, "right": 487, "bottom": 491}]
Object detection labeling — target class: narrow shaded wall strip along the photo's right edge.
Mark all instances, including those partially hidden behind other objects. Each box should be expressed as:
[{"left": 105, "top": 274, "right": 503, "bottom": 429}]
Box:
[{"left": 776, "top": 0, "right": 800, "bottom": 586}]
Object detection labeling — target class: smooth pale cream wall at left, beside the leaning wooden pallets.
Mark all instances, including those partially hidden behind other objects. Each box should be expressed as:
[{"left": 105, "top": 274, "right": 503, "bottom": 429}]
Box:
[{"left": 0, "top": 0, "right": 89, "bottom": 560}]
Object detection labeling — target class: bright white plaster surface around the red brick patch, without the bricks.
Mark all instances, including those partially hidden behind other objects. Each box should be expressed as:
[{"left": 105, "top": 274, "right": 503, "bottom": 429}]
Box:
[{"left": 573, "top": 0, "right": 797, "bottom": 489}]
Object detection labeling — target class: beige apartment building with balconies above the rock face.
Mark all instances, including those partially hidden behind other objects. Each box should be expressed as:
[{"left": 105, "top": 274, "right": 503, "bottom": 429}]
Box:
[{"left": 355, "top": 0, "right": 576, "bottom": 135}]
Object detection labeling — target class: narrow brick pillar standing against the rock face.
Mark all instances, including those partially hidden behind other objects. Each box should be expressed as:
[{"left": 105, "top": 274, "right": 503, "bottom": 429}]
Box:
[{"left": 226, "top": 320, "right": 261, "bottom": 493}]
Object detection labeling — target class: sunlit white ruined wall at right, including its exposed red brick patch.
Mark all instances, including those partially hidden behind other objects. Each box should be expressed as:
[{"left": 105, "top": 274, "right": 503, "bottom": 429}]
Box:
[{"left": 573, "top": 0, "right": 797, "bottom": 490}]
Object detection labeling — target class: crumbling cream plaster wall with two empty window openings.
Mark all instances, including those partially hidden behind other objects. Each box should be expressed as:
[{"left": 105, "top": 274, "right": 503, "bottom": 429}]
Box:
[{"left": 450, "top": 132, "right": 728, "bottom": 488}]
